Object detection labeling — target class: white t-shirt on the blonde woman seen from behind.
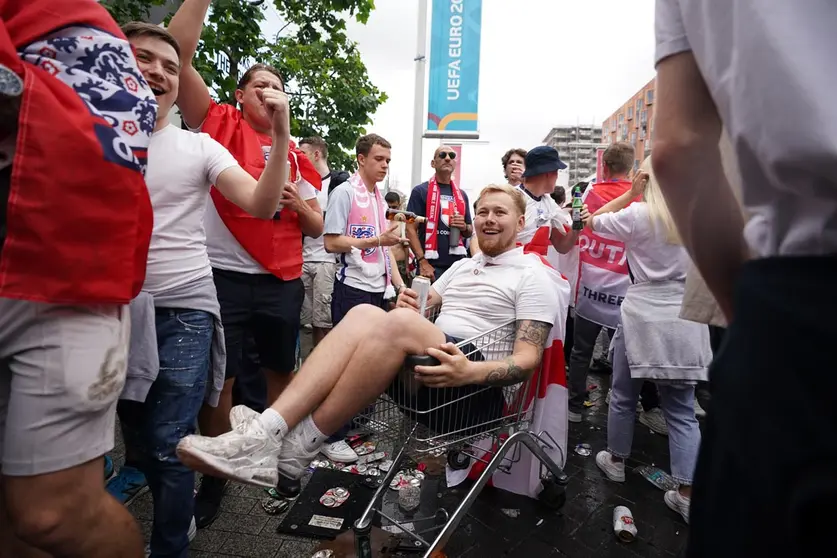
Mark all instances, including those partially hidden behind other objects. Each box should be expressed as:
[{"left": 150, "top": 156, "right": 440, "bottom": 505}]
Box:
[{"left": 593, "top": 202, "right": 691, "bottom": 283}]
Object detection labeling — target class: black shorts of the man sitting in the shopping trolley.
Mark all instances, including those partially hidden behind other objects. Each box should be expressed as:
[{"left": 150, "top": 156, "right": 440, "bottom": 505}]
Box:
[{"left": 387, "top": 334, "right": 505, "bottom": 435}]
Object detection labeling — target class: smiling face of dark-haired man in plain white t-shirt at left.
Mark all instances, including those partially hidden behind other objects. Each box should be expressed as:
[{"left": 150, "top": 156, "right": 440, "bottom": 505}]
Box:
[{"left": 129, "top": 35, "right": 180, "bottom": 123}]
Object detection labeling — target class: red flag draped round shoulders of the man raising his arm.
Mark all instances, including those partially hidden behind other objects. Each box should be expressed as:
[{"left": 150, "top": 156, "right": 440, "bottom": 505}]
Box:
[{"left": 201, "top": 102, "right": 322, "bottom": 281}]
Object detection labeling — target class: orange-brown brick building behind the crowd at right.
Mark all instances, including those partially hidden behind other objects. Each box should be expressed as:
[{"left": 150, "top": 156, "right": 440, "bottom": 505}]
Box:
[{"left": 601, "top": 78, "right": 657, "bottom": 168}]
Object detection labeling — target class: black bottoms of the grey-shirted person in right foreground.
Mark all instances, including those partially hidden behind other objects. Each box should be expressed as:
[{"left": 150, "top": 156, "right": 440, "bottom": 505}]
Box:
[{"left": 686, "top": 257, "right": 837, "bottom": 558}]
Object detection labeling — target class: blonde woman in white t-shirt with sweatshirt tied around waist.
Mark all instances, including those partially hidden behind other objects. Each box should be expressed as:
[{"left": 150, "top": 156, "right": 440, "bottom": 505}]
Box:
[{"left": 587, "top": 158, "right": 712, "bottom": 522}]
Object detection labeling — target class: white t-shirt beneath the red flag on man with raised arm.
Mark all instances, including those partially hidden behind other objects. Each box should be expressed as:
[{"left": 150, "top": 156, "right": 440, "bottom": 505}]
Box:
[{"left": 206, "top": 146, "right": 317, "bottom": 275}]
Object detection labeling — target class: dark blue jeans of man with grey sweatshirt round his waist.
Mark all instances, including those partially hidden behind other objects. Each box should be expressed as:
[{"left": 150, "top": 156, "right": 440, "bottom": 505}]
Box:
[{"left": 119, "top": 308, "right": 215, "bottom": 558}]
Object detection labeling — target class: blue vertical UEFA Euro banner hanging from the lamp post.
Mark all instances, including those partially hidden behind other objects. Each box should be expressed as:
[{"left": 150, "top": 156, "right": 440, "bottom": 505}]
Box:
[{"left": 427, "top": 0, "right": 482, "bottom": 138}]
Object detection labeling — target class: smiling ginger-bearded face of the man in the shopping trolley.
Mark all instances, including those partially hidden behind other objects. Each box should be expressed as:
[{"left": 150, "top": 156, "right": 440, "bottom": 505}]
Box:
[{"left": 474, "top": 191, "right": 524, "bottom": 257}]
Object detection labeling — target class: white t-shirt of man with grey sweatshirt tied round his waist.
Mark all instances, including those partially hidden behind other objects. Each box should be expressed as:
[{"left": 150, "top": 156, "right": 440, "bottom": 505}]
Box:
[{"left": 143, "top": 125, "right": 238, "bottom": 295}]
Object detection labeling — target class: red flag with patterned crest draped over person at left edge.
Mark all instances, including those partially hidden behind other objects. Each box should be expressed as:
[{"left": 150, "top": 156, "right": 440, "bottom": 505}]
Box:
[{"left": 0, "top": 0, "right": 157, "bottom": 304}]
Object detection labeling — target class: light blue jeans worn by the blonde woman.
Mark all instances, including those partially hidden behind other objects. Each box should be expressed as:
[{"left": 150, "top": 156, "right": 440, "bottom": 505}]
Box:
[{"left": 607, "top": 328, "right": 700, "bottom": 485}]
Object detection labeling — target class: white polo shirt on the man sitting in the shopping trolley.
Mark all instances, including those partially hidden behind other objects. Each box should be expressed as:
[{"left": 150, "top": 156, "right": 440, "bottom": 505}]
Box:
[{"left": 432, "top": 248, "right": 560, "bottom": 360}]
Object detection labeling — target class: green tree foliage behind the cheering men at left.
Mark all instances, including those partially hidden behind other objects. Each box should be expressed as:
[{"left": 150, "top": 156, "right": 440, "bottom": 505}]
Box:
[{"left": 102, "top": 0, "right": 387, "bottom": 170}]
